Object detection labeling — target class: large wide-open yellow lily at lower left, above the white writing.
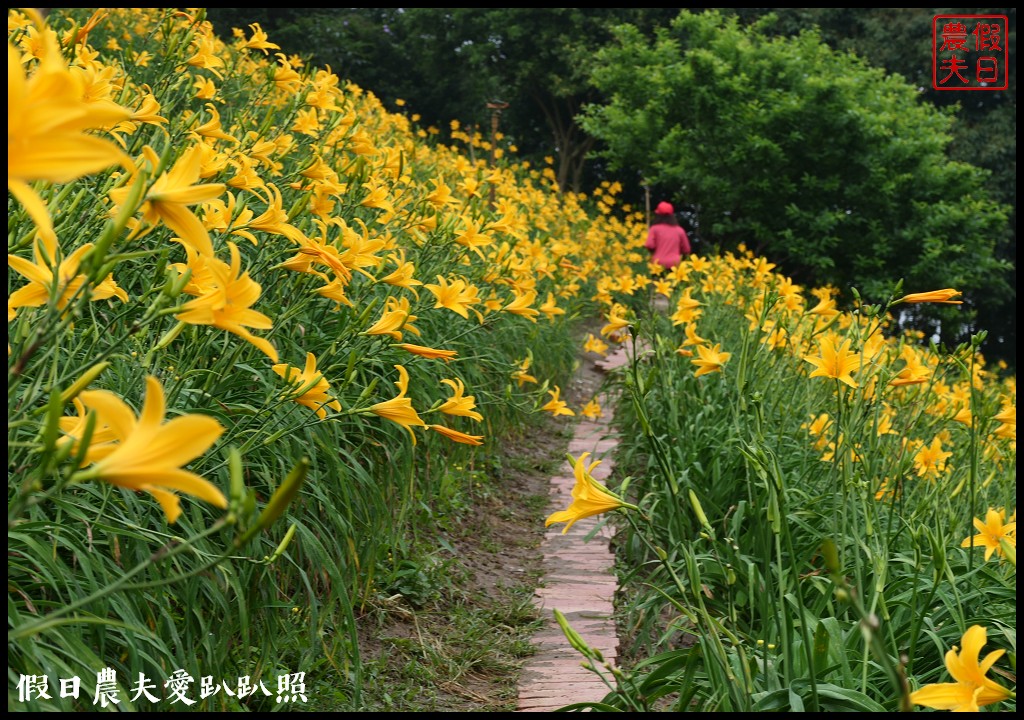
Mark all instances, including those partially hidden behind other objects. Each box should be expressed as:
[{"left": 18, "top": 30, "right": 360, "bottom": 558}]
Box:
[{"left": 69, "top": 376, "right": 227, "bottom": 522}]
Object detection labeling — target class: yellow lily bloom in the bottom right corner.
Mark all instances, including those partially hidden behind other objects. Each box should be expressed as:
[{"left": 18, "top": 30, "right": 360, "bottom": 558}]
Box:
[{"left": 910, "top": 625, "right": 1012, "bottom": 713}]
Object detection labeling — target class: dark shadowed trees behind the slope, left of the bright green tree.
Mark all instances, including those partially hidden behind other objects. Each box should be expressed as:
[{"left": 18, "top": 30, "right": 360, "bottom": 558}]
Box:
[{"left": 201, "top": 7, "right": 675, "bottom": 192}]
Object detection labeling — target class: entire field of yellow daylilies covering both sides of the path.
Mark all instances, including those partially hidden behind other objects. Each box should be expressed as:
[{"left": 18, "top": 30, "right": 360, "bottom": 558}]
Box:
[{"left": 7, "top": 8, "right": 1016, "bottom": 710}]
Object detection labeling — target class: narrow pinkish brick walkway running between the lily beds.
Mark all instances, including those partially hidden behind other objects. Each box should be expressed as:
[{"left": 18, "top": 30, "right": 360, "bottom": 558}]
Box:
[{"left": 518, "top": 345, "right": 627, "bottom": 713}]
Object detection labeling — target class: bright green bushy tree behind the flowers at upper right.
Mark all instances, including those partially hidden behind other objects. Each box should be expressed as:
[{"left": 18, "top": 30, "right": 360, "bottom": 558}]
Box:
[{"left": 582, "top": 11, "right": 1009, "bottom": 348}]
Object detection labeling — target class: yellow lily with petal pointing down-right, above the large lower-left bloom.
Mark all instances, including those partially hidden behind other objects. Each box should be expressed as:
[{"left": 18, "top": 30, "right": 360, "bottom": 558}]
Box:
[{"left": 174, "top": 243, "right": 278, "bottom": 363}]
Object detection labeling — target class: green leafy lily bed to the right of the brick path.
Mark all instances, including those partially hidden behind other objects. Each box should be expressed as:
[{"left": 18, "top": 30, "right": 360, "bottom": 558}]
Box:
[{"left": 584, "top": 253, "right": 1016, "bottom": 712}]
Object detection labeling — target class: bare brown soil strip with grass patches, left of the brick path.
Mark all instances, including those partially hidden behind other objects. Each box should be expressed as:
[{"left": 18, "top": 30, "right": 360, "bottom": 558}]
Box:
[{"left": 359, "top": 320, "right": 605, "bottom": 712}]
